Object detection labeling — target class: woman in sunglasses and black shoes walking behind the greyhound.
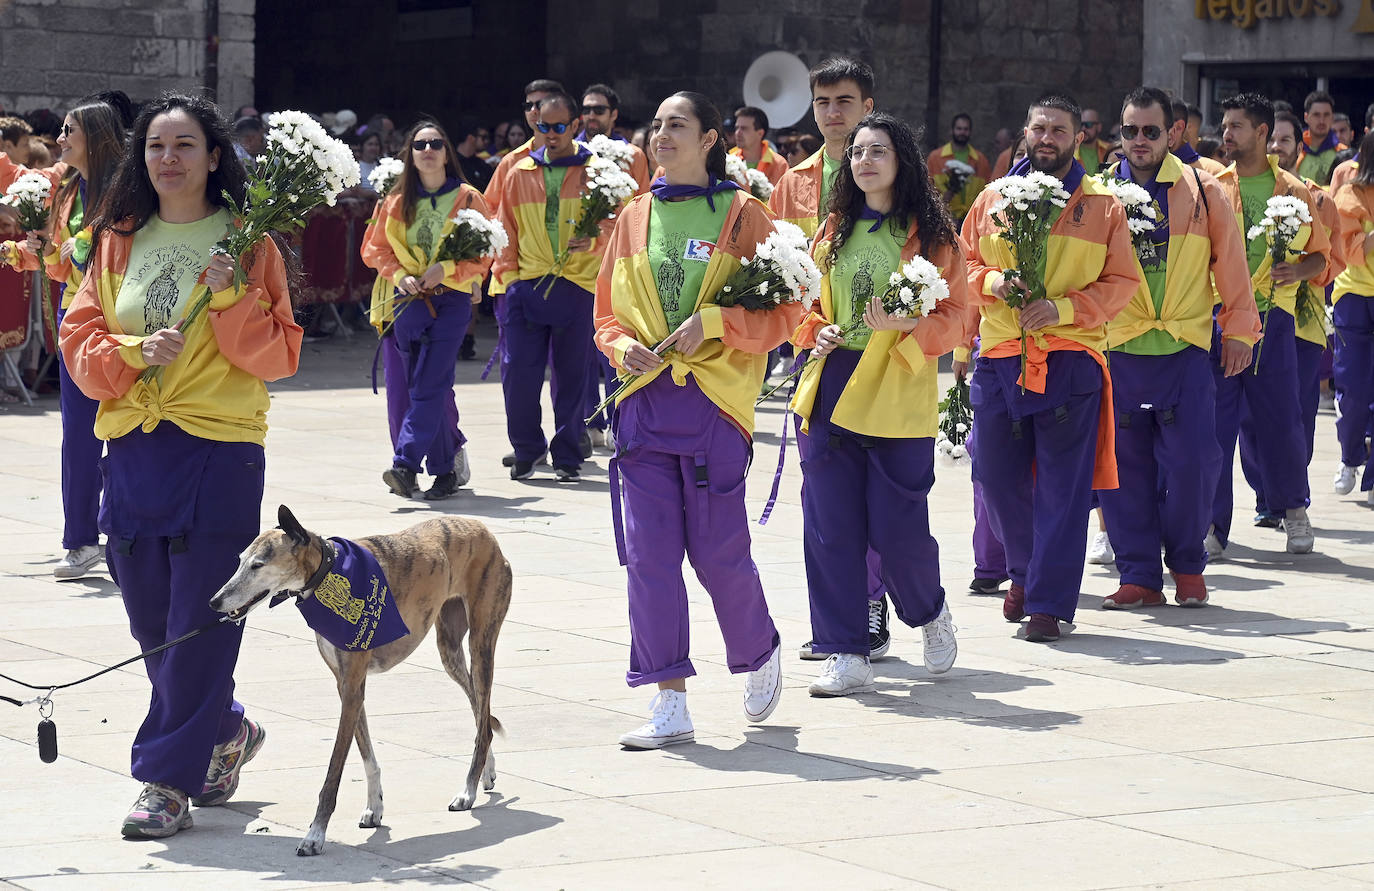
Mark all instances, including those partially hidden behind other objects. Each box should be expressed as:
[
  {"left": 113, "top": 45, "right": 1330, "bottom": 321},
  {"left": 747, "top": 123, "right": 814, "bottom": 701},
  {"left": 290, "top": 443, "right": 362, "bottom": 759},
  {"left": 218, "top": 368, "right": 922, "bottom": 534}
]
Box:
[{"left": 363, "top": 121, "right": 492, "bottom": 501}]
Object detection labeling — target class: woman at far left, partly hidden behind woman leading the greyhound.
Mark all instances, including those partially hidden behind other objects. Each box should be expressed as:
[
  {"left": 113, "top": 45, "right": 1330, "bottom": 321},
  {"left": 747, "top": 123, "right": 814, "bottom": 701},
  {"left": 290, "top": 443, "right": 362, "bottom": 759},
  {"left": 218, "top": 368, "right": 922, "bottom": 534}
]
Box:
[{"left": 0, "top": 94, "right": 124, "bottom": 579}]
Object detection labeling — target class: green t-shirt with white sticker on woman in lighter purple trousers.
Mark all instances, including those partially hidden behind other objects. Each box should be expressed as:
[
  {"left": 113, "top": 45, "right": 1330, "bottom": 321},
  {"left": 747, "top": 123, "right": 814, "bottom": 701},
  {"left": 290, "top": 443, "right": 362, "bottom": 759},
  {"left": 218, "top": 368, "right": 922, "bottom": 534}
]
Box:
[{"left": 649, "top": 194, "right": 731, "bottom": 331}]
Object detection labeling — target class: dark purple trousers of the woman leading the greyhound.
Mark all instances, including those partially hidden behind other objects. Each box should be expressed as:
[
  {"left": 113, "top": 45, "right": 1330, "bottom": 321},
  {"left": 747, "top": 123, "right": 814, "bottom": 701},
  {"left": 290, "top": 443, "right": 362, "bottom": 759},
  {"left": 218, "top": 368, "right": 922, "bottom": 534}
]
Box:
[{"left": 100, "top": 421, "right": 265, "bottom": 795}]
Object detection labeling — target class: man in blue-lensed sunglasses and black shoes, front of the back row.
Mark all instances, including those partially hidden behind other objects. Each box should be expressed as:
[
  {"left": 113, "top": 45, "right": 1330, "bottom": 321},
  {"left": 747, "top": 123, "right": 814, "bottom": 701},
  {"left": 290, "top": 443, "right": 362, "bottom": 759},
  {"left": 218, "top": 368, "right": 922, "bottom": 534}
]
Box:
[{"left": 492, "top": 92, "right": 609, "bottom": 483}]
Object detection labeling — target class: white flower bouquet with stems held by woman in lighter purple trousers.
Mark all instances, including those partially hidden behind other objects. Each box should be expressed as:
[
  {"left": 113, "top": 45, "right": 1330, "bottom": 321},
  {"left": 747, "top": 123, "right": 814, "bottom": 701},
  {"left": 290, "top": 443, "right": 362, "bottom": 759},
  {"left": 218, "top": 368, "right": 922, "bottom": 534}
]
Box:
[{"left": 588, "top": 220, "right": 820, "bottom": 421}]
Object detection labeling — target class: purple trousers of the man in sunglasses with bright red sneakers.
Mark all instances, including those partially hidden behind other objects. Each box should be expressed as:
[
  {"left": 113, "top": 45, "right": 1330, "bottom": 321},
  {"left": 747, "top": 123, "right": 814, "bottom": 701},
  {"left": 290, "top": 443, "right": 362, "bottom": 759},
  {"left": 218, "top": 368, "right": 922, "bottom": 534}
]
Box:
[{"left": 1098, "top": 347, "right": 1221, "bottom": 591}]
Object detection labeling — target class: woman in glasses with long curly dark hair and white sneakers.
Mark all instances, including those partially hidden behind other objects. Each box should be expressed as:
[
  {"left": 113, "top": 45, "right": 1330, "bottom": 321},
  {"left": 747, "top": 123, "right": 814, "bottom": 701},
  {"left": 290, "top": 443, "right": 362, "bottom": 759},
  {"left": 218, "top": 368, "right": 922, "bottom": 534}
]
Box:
[{"left": 793, "top": 113, "right": 967, "bottom": 696}]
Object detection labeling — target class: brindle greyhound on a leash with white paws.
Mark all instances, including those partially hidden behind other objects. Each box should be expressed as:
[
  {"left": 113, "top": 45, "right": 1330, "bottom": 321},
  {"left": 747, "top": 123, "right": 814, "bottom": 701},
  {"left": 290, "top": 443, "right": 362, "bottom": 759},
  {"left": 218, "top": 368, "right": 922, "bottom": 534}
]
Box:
[{"left": 210, "top": 505, "right": 511, "bottom": 857}]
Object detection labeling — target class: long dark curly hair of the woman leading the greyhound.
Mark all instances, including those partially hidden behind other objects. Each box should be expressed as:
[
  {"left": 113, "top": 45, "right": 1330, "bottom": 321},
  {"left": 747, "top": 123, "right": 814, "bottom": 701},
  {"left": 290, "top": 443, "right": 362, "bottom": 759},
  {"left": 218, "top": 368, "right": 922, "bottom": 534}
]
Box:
[{"left": 93, "top": 92, "right": 247, "bottom": 241}]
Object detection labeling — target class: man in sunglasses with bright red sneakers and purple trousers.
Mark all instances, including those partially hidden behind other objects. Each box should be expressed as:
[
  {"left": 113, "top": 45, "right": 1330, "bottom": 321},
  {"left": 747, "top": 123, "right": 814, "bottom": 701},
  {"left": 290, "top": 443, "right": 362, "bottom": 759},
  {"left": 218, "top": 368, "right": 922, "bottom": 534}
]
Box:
[{"left": 1098, "top": 87, "right": 1260, "bottom": 609}]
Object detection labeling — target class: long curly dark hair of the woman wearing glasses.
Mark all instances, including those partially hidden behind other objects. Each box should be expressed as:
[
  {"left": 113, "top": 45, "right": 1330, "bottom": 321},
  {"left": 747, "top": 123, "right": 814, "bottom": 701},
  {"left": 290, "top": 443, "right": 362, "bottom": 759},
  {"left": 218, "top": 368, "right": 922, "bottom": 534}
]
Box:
[{"left": 826, "top": 111, "right": 956, "bottom": 268}]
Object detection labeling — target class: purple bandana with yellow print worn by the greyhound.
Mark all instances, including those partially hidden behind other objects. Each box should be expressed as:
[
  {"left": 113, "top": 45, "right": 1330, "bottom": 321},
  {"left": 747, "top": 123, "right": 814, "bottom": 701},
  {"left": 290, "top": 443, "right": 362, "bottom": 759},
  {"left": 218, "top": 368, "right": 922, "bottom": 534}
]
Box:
[{"left": 295, "top": 538, "right": 411, "bottom": 650}]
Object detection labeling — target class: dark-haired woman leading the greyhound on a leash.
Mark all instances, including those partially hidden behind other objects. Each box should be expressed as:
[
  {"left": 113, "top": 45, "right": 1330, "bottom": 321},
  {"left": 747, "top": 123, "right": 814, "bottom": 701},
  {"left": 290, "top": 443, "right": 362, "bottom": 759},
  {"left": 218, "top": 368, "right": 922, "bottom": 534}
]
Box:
[{"left": 62, "top": 94, "right": 301, "bottom": 837}]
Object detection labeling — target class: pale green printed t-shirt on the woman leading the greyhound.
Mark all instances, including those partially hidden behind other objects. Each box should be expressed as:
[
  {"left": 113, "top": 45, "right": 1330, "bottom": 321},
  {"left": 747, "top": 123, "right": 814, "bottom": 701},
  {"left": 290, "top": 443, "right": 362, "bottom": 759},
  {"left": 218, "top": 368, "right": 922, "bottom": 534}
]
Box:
[{"left": 114, "top": 208, "right": 229, "bottom": 334}]
